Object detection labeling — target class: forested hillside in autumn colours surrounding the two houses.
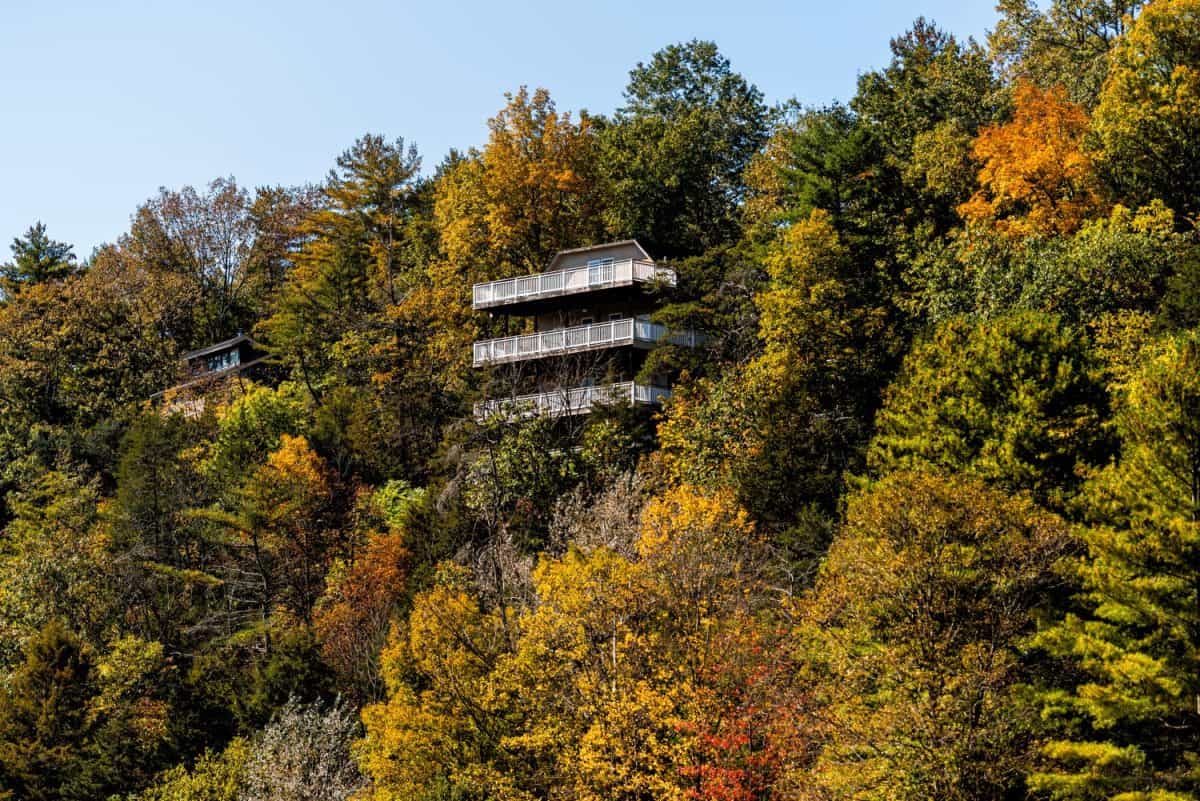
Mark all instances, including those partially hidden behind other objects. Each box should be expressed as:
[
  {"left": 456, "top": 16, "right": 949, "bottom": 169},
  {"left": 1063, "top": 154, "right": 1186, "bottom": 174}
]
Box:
[{"left": 0, "top": 0, "right": 1200, "bottom": 801}]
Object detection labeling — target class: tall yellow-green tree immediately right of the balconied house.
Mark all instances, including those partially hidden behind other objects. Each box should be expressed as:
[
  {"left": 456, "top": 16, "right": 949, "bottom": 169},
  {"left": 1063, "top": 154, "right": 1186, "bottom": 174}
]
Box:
[{"left": 659, "top": 211, "right": 893, "bottom": 528}]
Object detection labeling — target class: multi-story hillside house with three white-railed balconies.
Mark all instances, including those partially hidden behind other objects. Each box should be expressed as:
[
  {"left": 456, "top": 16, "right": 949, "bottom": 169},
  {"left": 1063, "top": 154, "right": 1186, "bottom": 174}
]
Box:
[{"left": 473, "top": 240, "right": 696, "bottom": 417}]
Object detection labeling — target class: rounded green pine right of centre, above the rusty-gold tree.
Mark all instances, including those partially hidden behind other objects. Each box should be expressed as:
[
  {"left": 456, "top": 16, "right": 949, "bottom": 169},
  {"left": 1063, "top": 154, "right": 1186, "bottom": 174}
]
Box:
[{"left": 866, "top": 313, "right": 1111, "bottom": 508}]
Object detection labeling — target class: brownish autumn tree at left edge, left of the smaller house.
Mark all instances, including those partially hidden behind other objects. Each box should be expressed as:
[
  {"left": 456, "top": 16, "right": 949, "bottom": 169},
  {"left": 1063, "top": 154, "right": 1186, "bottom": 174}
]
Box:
[{"left": 0, "top": 248, "right": 190, "bottom": 515}]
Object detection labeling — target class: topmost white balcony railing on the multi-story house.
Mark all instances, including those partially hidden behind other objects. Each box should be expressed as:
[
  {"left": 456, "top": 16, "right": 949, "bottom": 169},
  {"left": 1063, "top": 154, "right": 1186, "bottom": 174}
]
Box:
[{"left": 472, "top": 259, "right": 676, "bottom": 308}]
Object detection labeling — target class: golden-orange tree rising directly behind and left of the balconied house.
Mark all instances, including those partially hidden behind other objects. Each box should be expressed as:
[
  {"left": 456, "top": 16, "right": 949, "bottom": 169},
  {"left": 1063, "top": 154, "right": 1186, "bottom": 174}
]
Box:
[{"left": 392, "top": 88, "right": 602, "bottom": 407}]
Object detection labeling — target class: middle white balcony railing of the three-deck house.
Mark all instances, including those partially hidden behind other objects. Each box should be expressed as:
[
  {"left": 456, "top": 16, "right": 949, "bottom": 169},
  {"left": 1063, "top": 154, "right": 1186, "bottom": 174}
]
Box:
[{"left": 474, "top": 318, "right": 697, "bottom": 367}]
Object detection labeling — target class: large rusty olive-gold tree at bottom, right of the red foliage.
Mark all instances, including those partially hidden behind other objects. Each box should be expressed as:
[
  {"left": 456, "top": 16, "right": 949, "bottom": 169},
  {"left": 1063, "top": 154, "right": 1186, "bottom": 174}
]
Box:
[{"left": 806, "top": 474, "right": 1072, "bottom": 801}]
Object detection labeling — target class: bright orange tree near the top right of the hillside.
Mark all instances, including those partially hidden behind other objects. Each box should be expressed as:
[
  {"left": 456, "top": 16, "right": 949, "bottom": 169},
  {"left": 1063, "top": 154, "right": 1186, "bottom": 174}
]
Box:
[{"left": 959, "top": 83, "right": 1108, "bottom": 237}]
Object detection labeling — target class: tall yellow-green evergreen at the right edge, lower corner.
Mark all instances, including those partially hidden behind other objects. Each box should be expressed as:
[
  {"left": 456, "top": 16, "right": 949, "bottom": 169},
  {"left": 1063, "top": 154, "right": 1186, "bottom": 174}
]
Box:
[{"left": 1033, "top": 330, "right": 1200, "bottom": 801}]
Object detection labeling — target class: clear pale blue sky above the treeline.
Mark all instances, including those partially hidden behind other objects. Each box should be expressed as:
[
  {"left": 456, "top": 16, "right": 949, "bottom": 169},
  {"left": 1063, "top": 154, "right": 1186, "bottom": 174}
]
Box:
[{"left": 0, "top": 0, "right": 996, "bottom": 260}]
